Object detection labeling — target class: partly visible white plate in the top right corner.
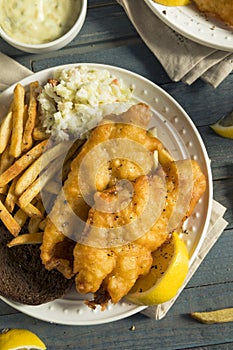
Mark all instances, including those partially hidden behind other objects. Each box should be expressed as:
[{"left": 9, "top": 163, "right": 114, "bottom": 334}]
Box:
[{"left": 144, "top": 0, "right": 233, "bottom": 51}]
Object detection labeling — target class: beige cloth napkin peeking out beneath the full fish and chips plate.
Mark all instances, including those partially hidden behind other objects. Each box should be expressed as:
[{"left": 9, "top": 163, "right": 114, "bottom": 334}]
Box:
[{"left": 0, "top": 53, "right": 227, "bottom": 319}]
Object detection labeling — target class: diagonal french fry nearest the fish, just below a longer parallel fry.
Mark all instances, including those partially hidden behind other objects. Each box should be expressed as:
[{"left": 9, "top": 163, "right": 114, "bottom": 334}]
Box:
[{"left": 19, "top": 156, "right": 62, "bottom": 207}]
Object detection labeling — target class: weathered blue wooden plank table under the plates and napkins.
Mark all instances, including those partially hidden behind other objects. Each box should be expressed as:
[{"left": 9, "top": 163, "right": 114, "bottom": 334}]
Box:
[{"left": 0, "top": 0, "right": 233, "bottom": 350}]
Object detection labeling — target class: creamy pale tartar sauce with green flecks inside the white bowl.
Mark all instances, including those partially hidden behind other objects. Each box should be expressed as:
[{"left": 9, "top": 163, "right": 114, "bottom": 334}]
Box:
[{"left": 0, "top": 0, "right": 80, "bottom": 44}]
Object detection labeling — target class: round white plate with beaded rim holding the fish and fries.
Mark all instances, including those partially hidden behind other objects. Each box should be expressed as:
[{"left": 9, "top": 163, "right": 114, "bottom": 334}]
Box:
[{"left": 0, "top": 64, "right": 212, "bottom": 325}]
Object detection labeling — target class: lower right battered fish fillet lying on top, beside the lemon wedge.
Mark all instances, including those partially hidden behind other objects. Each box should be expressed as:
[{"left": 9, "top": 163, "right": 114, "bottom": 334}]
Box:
[{"left": 74, "top": 160, "right": 206, "bottom": 307}]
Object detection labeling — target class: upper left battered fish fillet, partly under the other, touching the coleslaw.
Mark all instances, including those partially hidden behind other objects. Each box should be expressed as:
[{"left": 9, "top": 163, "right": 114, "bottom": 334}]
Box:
[{"left": 41, "top": 103, "right": 162, "bottom": 278}]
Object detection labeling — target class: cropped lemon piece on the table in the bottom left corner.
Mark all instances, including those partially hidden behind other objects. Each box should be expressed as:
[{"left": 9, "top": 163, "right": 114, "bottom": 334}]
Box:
[{"left": 0, "top": 329, "right": 46, "bottom": 350}]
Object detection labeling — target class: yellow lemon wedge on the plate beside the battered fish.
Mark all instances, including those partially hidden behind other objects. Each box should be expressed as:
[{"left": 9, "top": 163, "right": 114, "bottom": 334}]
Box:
[{"left": 126, "top": 232, "right": 189, "bottom": 305}]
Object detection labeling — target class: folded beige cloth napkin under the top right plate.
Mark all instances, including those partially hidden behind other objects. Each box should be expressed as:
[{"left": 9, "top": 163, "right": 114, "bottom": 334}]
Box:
[{"left": 117, "top": 0, "right": 233, "bottom": 87}]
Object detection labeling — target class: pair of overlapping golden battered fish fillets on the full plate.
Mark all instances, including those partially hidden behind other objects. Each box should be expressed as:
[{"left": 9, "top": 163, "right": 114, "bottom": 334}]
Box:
[{"left": 41, "top": 103, "right": 206, "bottom": 308}]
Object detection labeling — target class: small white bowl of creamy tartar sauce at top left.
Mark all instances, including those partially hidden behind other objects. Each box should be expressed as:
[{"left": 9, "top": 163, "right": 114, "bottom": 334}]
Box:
[{"left": 0, "top": 0, "right": 87, "bottom": 53}]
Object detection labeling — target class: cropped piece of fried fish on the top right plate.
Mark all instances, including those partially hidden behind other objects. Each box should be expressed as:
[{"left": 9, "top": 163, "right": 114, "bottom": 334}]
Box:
[{"left": 193, "top": 0, "right": 233, "bottom": 26}]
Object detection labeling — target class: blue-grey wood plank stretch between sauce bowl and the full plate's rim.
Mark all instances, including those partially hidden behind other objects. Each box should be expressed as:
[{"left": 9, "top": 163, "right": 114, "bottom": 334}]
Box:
[{"left": 17, "top": 38, "right": 170, "bottom": 84}]
